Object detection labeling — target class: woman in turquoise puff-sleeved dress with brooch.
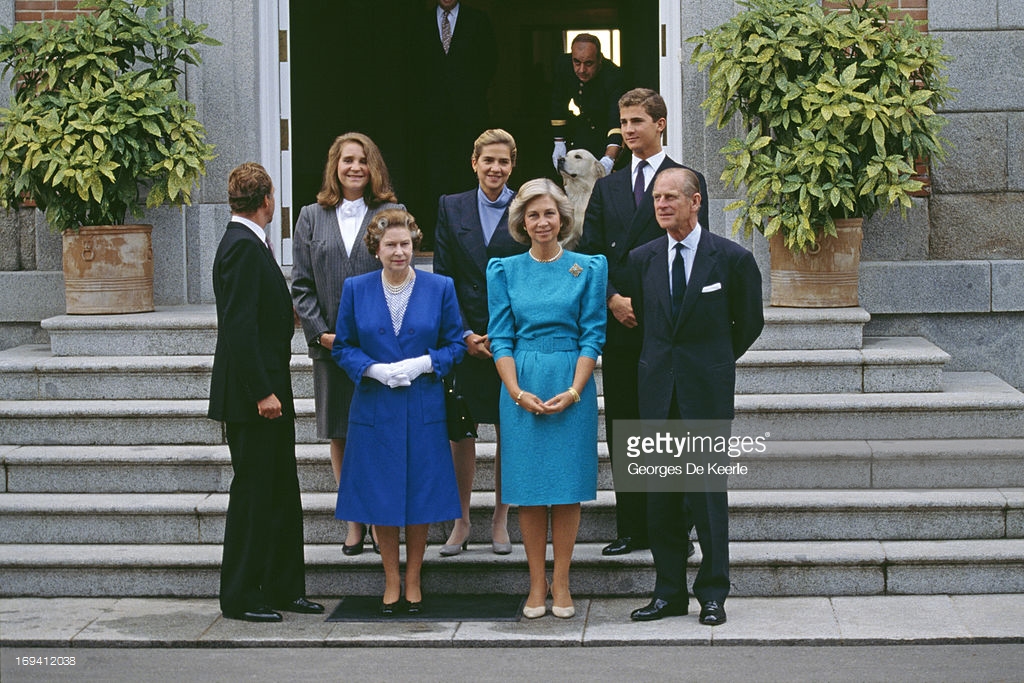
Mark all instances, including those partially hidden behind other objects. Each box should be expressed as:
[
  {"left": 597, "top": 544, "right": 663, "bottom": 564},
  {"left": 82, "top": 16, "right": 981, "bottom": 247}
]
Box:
[{"left": 486, "top": 178, "right": 608, "bottom": 618}]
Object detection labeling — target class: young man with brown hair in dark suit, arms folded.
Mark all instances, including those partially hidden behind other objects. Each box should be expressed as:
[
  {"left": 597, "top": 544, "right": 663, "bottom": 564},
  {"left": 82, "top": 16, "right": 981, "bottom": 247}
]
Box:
[{"left": 578, "top": 88, "right": 708, "bottom": 555}]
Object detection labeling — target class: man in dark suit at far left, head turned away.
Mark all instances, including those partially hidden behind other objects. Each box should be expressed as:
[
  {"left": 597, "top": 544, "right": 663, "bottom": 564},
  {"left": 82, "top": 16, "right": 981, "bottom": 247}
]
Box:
[{"left": 208, "top": 163, "right": 324, "bottom": 623}]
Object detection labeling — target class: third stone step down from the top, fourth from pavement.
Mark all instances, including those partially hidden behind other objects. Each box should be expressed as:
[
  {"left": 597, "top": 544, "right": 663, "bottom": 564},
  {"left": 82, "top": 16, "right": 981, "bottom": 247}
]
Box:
[{"left": 0, "top": 373, "right": 1024, "bottom": 445}]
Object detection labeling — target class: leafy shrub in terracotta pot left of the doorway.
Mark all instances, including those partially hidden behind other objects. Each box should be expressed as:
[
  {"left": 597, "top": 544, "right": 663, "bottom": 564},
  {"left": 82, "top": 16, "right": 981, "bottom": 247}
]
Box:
[{"left": 0, "top": 0, "right": 218, "bottom": 313}]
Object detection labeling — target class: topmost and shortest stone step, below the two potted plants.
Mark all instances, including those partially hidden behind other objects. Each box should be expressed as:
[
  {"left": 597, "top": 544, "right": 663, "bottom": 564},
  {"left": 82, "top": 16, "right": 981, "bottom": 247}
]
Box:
[{"left": 40, "top": 304, "right": 870, "bottom": 355}]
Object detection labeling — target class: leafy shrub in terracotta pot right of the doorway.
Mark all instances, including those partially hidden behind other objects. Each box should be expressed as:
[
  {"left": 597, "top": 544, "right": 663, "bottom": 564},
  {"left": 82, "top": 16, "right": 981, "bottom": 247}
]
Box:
[{"left": 689, "top": 0, "right": 952, "bottom": 306}]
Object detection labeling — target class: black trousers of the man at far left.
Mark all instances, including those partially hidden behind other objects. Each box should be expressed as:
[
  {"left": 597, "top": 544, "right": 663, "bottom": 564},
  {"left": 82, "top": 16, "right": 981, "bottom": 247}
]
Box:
[{"left": 220, "top": 418, "right": 306, "bottom": 613}]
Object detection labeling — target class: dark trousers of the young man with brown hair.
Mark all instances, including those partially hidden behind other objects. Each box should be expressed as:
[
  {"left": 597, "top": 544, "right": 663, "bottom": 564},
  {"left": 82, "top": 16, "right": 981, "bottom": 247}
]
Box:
[{"left": 601, "top": 346, "right": 647, "bottom": 547}]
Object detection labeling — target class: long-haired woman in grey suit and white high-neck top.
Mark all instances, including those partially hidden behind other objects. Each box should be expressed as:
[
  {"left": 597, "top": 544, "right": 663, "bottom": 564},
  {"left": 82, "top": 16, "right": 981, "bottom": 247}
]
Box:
[{"left": 292, "top": 133, "right": 404, "bottom": 555}]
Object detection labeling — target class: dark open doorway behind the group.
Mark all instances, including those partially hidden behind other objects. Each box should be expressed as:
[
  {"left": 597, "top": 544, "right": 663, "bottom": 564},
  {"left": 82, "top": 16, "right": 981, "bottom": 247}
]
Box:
[{"left": 290, "top": 0, "right": 659, "bottom": 249}]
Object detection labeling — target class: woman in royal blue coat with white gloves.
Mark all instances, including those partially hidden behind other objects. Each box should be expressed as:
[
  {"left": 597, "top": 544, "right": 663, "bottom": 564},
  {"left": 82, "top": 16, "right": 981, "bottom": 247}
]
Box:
[{"left": 332, "top": 209, "right": 466, "bottom": 615}]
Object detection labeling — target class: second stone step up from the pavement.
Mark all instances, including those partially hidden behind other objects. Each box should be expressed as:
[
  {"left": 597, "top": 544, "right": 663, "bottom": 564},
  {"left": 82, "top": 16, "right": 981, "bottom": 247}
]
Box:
[{"left": 0, "top": 488, "right": 1024, "bottom": 545}]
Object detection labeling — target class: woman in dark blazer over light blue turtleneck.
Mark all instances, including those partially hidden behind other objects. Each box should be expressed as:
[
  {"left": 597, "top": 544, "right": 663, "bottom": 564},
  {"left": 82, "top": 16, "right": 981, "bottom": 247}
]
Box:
[{"left": 434, "top": 128, "right": 526, "bottom": 556}]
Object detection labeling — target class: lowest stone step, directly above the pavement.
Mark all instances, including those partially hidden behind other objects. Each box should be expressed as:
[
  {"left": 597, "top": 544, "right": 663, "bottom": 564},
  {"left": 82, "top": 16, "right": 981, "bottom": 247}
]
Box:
[{"left": 0, "top": 539, "right": 1024, "bottom": 598}]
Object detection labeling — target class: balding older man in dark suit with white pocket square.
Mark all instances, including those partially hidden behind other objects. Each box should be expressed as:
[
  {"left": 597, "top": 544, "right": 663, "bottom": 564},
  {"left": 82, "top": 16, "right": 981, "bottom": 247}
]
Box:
[{"left": 628, "top": 169, "right": 764, "bottom": 626}]
